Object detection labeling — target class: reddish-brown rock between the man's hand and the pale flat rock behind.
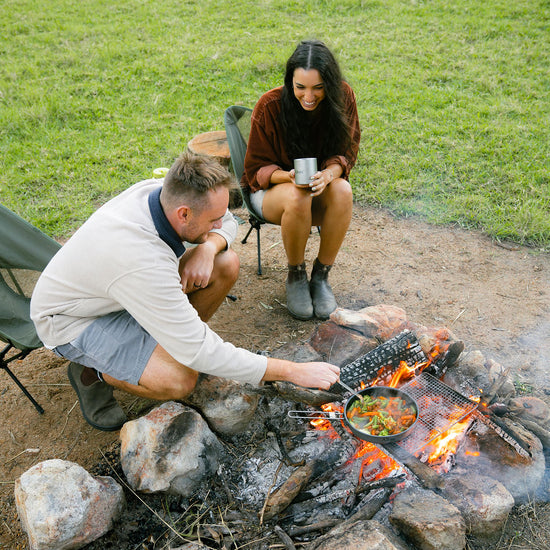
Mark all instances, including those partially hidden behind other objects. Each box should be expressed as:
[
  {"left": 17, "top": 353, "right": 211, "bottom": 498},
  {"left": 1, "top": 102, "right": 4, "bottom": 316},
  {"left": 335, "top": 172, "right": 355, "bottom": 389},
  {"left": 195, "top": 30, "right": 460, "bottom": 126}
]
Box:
[{"left": 309, "top": 321, "right": 378, "bottom": 367}]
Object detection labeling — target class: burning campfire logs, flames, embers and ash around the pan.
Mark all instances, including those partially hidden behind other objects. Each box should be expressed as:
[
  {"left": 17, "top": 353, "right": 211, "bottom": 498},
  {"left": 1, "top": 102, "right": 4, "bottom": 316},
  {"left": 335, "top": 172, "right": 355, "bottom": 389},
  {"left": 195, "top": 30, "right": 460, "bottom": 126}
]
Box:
[{"left": 227, "top": 314, "right": 544, "bottom": 548}]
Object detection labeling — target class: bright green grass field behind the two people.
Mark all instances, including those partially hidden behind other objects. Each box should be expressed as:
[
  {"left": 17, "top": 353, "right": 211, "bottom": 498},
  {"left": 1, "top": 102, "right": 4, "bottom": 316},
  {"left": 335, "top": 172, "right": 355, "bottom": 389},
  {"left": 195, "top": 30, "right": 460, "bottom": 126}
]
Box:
[{"left": 0, "top": 0, "right": 550, "bottom": 249}]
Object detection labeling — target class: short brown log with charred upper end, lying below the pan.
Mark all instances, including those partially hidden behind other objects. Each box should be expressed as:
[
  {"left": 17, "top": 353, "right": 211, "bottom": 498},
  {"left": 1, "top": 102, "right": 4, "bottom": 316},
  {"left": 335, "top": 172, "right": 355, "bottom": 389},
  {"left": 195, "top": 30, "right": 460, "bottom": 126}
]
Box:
[{"left": 263, "top": 440, "right": 362, "bottom": 520}]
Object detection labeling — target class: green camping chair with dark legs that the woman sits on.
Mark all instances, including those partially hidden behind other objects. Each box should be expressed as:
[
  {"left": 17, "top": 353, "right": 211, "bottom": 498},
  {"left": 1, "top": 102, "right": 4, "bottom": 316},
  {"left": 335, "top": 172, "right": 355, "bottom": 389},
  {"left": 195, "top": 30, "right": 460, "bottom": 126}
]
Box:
[{"left": 223, "top": 105, "right": 268, "bottom": 275}]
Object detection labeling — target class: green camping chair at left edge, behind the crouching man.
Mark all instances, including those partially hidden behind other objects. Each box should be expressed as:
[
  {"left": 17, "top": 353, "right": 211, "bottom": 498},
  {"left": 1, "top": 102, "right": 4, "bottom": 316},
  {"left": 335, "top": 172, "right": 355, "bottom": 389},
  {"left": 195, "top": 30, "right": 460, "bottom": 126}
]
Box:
[{"left": 0, "top": 204, "right": 61, "bottom": 414}]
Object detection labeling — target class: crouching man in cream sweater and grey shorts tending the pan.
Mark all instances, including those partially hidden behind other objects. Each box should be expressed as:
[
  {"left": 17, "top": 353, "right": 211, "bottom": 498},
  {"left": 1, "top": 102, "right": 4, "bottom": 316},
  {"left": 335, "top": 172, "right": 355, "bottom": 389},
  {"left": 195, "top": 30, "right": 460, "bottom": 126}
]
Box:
[{"left": 31, "top": 153, "right": 339, "bottom": 431}]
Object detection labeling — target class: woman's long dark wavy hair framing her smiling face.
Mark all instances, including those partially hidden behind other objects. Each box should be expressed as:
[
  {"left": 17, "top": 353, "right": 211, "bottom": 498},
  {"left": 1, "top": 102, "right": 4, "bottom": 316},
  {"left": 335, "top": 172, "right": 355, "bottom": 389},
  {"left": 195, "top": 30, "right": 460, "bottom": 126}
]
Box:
[{"left": 280, "top": 40, "right": 351, "bottom": 160}]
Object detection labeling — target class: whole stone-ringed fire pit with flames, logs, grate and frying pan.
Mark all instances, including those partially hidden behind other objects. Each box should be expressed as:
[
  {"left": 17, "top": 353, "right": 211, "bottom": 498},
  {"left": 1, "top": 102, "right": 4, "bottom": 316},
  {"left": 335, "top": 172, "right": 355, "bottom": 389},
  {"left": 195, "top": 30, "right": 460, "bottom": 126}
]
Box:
[{"left": 16, "top": 306, "right": 550, "bottom": 550}]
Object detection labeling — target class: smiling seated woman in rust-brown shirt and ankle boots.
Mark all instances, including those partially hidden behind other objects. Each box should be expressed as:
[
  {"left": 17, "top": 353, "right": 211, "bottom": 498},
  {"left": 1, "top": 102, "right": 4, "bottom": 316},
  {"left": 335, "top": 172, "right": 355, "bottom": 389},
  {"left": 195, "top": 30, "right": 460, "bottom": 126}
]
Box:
[{"left": 242, "top": 40, "right": 361, "bottom": 320}]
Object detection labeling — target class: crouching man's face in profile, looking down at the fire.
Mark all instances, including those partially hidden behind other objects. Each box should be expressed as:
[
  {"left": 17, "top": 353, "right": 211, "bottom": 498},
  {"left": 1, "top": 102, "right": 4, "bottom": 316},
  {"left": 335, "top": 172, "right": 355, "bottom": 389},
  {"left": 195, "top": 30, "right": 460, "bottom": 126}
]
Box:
[{"left": 180, "top": 187, "right": 229, "bottom": 244}]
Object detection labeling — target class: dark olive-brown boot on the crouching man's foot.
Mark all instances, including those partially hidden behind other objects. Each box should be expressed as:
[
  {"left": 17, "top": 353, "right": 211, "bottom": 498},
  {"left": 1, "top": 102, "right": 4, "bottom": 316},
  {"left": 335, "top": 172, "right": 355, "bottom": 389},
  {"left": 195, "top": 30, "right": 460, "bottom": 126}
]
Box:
[{"left": 67, "top": 362, "right": 127, "bottom": 432}]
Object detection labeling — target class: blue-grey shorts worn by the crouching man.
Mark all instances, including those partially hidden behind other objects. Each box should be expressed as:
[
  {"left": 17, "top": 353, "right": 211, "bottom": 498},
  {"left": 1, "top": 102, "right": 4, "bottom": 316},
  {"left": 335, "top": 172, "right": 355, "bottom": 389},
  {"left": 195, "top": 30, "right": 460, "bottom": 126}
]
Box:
[{"left": 53, "top": 311, "right": 157, "bottom": 385}]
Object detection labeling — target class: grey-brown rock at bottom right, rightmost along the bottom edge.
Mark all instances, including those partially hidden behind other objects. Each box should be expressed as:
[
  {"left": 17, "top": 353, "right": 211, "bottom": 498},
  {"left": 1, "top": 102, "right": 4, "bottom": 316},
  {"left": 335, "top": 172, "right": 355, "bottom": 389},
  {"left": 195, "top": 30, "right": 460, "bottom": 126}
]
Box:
[{"left": 443, "top": 472, "right": 514, "bottom": 544}]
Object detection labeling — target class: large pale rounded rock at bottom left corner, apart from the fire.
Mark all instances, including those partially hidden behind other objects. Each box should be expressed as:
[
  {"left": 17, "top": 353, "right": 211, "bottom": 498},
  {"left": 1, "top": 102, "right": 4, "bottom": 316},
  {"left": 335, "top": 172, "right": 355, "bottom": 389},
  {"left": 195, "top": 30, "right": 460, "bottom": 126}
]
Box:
[{"left": 15, "top": 459, "right": 125, "bottom": 550}]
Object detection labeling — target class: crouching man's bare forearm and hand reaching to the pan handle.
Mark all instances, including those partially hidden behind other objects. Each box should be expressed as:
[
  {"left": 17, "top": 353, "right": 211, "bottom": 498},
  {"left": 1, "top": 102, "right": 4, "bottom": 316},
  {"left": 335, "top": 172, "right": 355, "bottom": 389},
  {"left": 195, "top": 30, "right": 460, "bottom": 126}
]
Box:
[{"left": 263, "top": 357, "right": 340, "bottom": 390}]
